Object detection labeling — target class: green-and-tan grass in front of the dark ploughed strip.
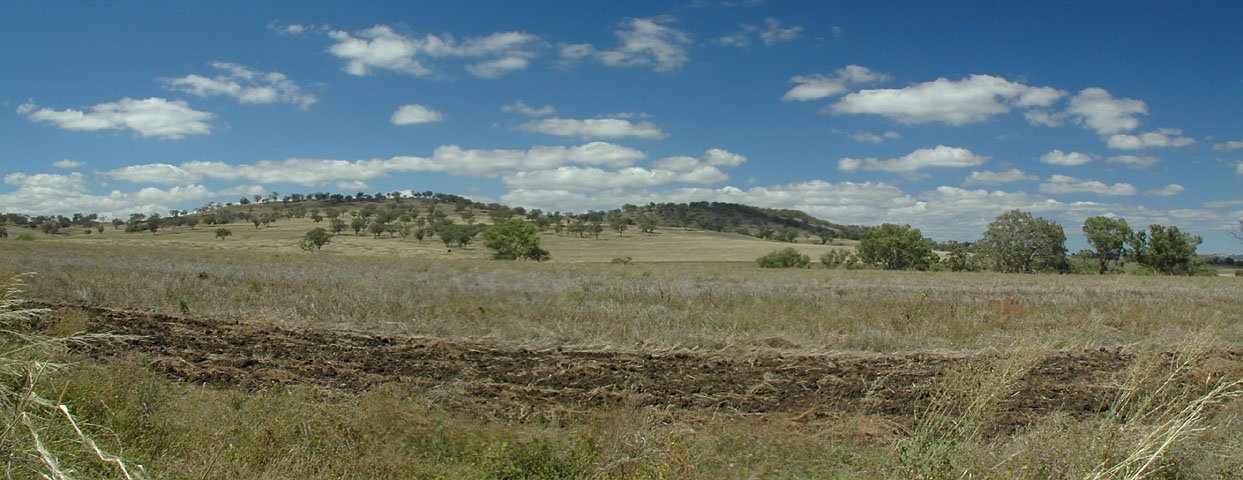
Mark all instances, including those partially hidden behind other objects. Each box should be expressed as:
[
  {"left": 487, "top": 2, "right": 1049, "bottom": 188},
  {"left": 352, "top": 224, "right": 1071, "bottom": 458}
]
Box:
[{"left": 34, "top": 338, "right": 1243, "bottom": 479}]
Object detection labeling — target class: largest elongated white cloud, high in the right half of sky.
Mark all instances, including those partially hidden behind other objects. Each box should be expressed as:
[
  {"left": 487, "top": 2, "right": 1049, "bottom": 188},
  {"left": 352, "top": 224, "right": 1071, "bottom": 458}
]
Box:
[{"left": 829, "top": 75, "right": 1065, "bottom": 126}]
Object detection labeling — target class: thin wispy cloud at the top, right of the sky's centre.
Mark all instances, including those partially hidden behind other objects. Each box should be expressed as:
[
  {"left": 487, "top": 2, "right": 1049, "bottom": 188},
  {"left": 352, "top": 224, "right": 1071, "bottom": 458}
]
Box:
[{"left": 561, "top": 16, "right": 691, "bottom": 72}]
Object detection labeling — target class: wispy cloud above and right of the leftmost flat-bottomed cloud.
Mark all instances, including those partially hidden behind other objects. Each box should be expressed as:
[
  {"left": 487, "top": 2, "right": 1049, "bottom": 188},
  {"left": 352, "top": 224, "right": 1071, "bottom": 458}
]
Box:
[{"left": 164, "top": 62, "right": 318, "bottom": 108}]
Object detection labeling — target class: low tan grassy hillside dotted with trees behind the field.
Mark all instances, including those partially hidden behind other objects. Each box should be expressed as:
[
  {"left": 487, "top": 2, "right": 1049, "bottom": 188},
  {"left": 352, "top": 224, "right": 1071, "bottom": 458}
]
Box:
[{"left": 7, "top": 194, "right": 855, "bottom": 262}]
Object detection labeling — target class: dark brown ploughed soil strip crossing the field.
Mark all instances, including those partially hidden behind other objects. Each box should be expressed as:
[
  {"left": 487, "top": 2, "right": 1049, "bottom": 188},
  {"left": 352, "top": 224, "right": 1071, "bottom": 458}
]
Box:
[{"left": 62, "top": 307, "right": 1243, "bottom": 430}]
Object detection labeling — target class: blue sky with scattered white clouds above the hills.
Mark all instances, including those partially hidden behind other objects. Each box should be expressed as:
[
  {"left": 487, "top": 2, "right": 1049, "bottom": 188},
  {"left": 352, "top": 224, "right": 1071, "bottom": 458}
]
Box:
[{"left": 0, "top": 0, "right": 1243, "bottom": 252}]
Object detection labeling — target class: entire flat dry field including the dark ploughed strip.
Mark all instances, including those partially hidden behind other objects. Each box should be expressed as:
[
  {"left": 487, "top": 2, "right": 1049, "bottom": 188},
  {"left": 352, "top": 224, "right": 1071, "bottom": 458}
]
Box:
[{"left": 0, "top": 226, "right": 1243, "bottom": 479}]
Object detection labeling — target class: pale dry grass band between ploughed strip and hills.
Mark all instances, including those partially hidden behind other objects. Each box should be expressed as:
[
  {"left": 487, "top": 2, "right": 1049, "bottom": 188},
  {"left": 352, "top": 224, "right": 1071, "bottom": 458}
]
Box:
[{"left": 4, "top": 241, "right": 1243, "bottom": 352}]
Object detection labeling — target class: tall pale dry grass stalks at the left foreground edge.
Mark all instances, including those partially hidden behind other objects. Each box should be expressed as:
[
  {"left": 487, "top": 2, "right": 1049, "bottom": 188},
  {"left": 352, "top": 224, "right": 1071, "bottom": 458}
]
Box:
[{"left": 0, "top": 274, "right": 145, "bottom": 480}]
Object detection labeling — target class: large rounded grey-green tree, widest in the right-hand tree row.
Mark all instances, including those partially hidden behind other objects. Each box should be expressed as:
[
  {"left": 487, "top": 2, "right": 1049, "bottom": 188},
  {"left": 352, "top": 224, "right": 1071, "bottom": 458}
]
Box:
[{"left": 978, "top": 210, "right": 1069, "bottom": 274}]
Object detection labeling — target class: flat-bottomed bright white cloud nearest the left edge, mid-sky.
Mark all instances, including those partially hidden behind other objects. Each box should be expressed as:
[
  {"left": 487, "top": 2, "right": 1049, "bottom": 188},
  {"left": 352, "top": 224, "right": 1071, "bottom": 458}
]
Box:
[{"left": 19, "top": 97, "right": 213, "bottom": 139}]
